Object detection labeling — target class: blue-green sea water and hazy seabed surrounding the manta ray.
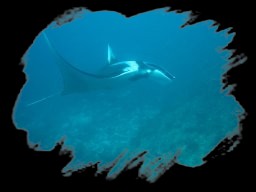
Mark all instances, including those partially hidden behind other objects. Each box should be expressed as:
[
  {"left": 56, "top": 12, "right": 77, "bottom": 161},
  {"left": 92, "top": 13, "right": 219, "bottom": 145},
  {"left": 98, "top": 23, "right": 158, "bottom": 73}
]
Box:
[{"left": 13, "top": 9, "right": 243, "bottom": 182}]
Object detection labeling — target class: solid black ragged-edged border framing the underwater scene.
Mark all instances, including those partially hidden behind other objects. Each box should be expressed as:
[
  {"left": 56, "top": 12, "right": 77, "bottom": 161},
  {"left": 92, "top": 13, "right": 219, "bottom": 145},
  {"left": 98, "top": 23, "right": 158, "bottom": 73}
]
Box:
[{"left": 4, "top": 0, "right": 256, "bottom": 191}]
